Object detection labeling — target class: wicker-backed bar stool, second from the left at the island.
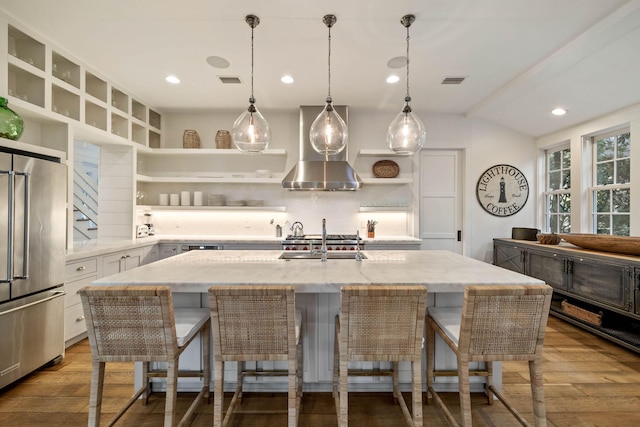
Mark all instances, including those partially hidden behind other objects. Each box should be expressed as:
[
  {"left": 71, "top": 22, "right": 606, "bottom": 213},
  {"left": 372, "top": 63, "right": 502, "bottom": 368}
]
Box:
[{"left": 209, "top": 285, "right": 302, "bottom": 427}]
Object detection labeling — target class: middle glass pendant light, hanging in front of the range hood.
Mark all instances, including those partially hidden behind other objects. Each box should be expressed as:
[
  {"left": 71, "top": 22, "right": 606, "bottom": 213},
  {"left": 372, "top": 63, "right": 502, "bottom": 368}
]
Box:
[{"left": 309, "top": 15, "right": 349, "bottom": 156}]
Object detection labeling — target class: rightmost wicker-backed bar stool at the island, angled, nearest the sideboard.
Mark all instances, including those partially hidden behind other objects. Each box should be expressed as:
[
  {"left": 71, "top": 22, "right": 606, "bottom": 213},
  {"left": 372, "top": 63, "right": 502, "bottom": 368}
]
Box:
[{"left": 427, "top": 285, "right": 553, "bottom": 427}]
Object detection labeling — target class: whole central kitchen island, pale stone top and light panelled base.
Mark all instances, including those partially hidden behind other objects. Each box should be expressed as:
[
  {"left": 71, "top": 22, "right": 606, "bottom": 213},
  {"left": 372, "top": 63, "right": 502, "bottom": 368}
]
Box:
[{"left": 93, "top": 250, "right": 543, "bottom": 391}]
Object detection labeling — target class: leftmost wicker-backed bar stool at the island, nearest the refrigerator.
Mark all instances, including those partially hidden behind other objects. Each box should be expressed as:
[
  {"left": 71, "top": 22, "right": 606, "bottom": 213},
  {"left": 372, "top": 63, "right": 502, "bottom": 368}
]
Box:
[{"left": 79, "top": 286, "right": 211, "bottom": 427}]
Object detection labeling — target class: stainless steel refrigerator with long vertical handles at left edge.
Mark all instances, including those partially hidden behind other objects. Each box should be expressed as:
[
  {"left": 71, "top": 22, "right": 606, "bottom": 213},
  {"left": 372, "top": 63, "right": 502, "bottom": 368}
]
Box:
[{"left": 0, "top": 145, "right": 67, "bottom": 388}]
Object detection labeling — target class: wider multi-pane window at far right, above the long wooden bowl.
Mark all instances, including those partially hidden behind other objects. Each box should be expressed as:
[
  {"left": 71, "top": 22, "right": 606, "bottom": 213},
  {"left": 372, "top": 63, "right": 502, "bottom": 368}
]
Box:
[{"left": 590, "top": 129, "right": 631, "bottom": 236}]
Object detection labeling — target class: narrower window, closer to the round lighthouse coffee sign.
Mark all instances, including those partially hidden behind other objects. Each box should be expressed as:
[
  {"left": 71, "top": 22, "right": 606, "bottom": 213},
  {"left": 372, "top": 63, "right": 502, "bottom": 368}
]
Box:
[{"left": 544, "top": 145, "right": 571, "bottom": 233}]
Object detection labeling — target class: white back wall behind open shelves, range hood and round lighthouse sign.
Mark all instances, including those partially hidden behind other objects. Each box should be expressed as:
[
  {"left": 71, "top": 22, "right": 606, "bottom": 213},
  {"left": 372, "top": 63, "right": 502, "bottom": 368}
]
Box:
[{"left": 154, "top": 109, "right": 537, "bottom": 262}]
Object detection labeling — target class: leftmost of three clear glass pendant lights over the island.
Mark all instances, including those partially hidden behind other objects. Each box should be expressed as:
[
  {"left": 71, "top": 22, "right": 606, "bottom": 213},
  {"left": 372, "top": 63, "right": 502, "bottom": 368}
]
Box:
[{"left": 231, "top": 15, "right": 271, "bottom": 154}]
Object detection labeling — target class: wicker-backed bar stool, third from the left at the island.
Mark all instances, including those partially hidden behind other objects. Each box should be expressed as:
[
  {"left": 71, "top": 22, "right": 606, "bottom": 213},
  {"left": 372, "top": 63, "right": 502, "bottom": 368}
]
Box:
[{"left": 333, "top": 285, "right": 427, "bottom": 427}]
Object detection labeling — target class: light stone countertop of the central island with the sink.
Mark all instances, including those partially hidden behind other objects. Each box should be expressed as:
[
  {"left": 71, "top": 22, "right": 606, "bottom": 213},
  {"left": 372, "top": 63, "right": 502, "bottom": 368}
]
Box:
[{"left": 93, "top": 250, "right": 543, "bottom": 293}]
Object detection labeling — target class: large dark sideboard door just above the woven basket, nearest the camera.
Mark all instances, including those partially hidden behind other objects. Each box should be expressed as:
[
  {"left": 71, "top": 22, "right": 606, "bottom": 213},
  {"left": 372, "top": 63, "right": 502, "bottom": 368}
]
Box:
[{"left": 569, "top": 258, "right": 632, "bottom": 311}]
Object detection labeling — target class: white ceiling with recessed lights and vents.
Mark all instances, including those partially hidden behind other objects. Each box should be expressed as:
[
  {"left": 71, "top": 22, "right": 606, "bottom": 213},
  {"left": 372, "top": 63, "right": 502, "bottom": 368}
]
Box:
[{"left": 0, "top": 0, "right": 640, "bottom": 136}]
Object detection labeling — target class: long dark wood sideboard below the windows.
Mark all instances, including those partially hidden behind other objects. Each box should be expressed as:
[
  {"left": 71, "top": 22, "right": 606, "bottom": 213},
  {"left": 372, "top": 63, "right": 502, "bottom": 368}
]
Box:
[{"left": 493, "top": 239, "right": 640, "bottom": 353}]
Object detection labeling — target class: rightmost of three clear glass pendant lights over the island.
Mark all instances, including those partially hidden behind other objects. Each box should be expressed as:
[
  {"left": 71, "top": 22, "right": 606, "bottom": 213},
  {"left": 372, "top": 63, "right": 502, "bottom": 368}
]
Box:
[{"left": 387, "top": 15, "right": 427, "bottom": 154}]
